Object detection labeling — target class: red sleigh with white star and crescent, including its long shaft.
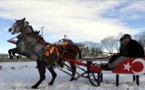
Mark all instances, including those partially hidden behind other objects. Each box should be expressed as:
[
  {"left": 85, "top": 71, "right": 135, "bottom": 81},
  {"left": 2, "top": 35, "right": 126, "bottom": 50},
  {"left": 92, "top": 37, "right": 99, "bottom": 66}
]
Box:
[{"left": 58, "top": 57, "right": 145, "bottom": 86}]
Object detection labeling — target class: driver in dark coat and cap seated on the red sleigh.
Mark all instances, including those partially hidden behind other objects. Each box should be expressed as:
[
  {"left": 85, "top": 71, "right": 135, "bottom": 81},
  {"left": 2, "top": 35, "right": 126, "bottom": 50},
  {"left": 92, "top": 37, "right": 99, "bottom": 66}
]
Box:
[{"left": 100, "top": 34, "right": 144, "bottom": 70}]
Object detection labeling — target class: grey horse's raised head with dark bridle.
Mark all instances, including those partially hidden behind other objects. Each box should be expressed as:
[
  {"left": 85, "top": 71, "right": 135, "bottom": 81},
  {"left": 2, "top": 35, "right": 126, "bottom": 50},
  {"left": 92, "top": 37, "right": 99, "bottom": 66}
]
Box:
[{"left": 9, "top": 18, "right": 33, "bottom": 34}]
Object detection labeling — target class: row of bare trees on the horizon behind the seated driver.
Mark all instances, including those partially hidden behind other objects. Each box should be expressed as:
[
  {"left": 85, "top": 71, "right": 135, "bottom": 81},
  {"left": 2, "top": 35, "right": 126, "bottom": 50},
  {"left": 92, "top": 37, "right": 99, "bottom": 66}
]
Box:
[{"left": 82, "top": 32, "right": 145, "bottom": 57}]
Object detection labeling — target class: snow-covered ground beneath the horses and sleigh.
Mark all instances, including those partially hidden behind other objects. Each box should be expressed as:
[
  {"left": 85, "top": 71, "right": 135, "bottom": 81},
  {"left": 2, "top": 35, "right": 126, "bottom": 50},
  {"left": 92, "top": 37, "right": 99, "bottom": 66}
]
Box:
[{"left": 0, "top": 61, "right": 145, "bottom": 90}]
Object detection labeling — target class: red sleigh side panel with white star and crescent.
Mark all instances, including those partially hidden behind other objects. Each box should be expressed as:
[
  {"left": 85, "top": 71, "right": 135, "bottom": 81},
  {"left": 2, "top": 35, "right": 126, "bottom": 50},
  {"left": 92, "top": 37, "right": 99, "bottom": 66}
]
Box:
[{"left": 112, "top": 58, "right": 145, "bottom": 75}]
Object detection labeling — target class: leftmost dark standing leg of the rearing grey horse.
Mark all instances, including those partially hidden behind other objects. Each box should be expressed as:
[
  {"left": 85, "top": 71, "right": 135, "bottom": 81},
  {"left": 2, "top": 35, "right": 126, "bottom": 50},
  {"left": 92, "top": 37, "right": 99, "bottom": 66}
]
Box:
[{"left": 32, "top": 60, "right": 46, "bottom": 89}]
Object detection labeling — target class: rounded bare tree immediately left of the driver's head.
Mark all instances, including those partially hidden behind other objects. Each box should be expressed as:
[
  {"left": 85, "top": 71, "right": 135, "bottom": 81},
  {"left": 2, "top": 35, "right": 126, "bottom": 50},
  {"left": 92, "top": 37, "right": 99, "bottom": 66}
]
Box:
[{"left": 101, "top": 36, "right": 119, "bottom": 53}]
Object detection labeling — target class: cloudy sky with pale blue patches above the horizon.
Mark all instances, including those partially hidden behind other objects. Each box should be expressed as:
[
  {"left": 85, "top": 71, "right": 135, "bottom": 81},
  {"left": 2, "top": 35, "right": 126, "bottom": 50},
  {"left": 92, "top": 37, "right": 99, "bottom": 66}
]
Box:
[{"left": 0, "top": 0, "right": 145, "bottom": 53}]
